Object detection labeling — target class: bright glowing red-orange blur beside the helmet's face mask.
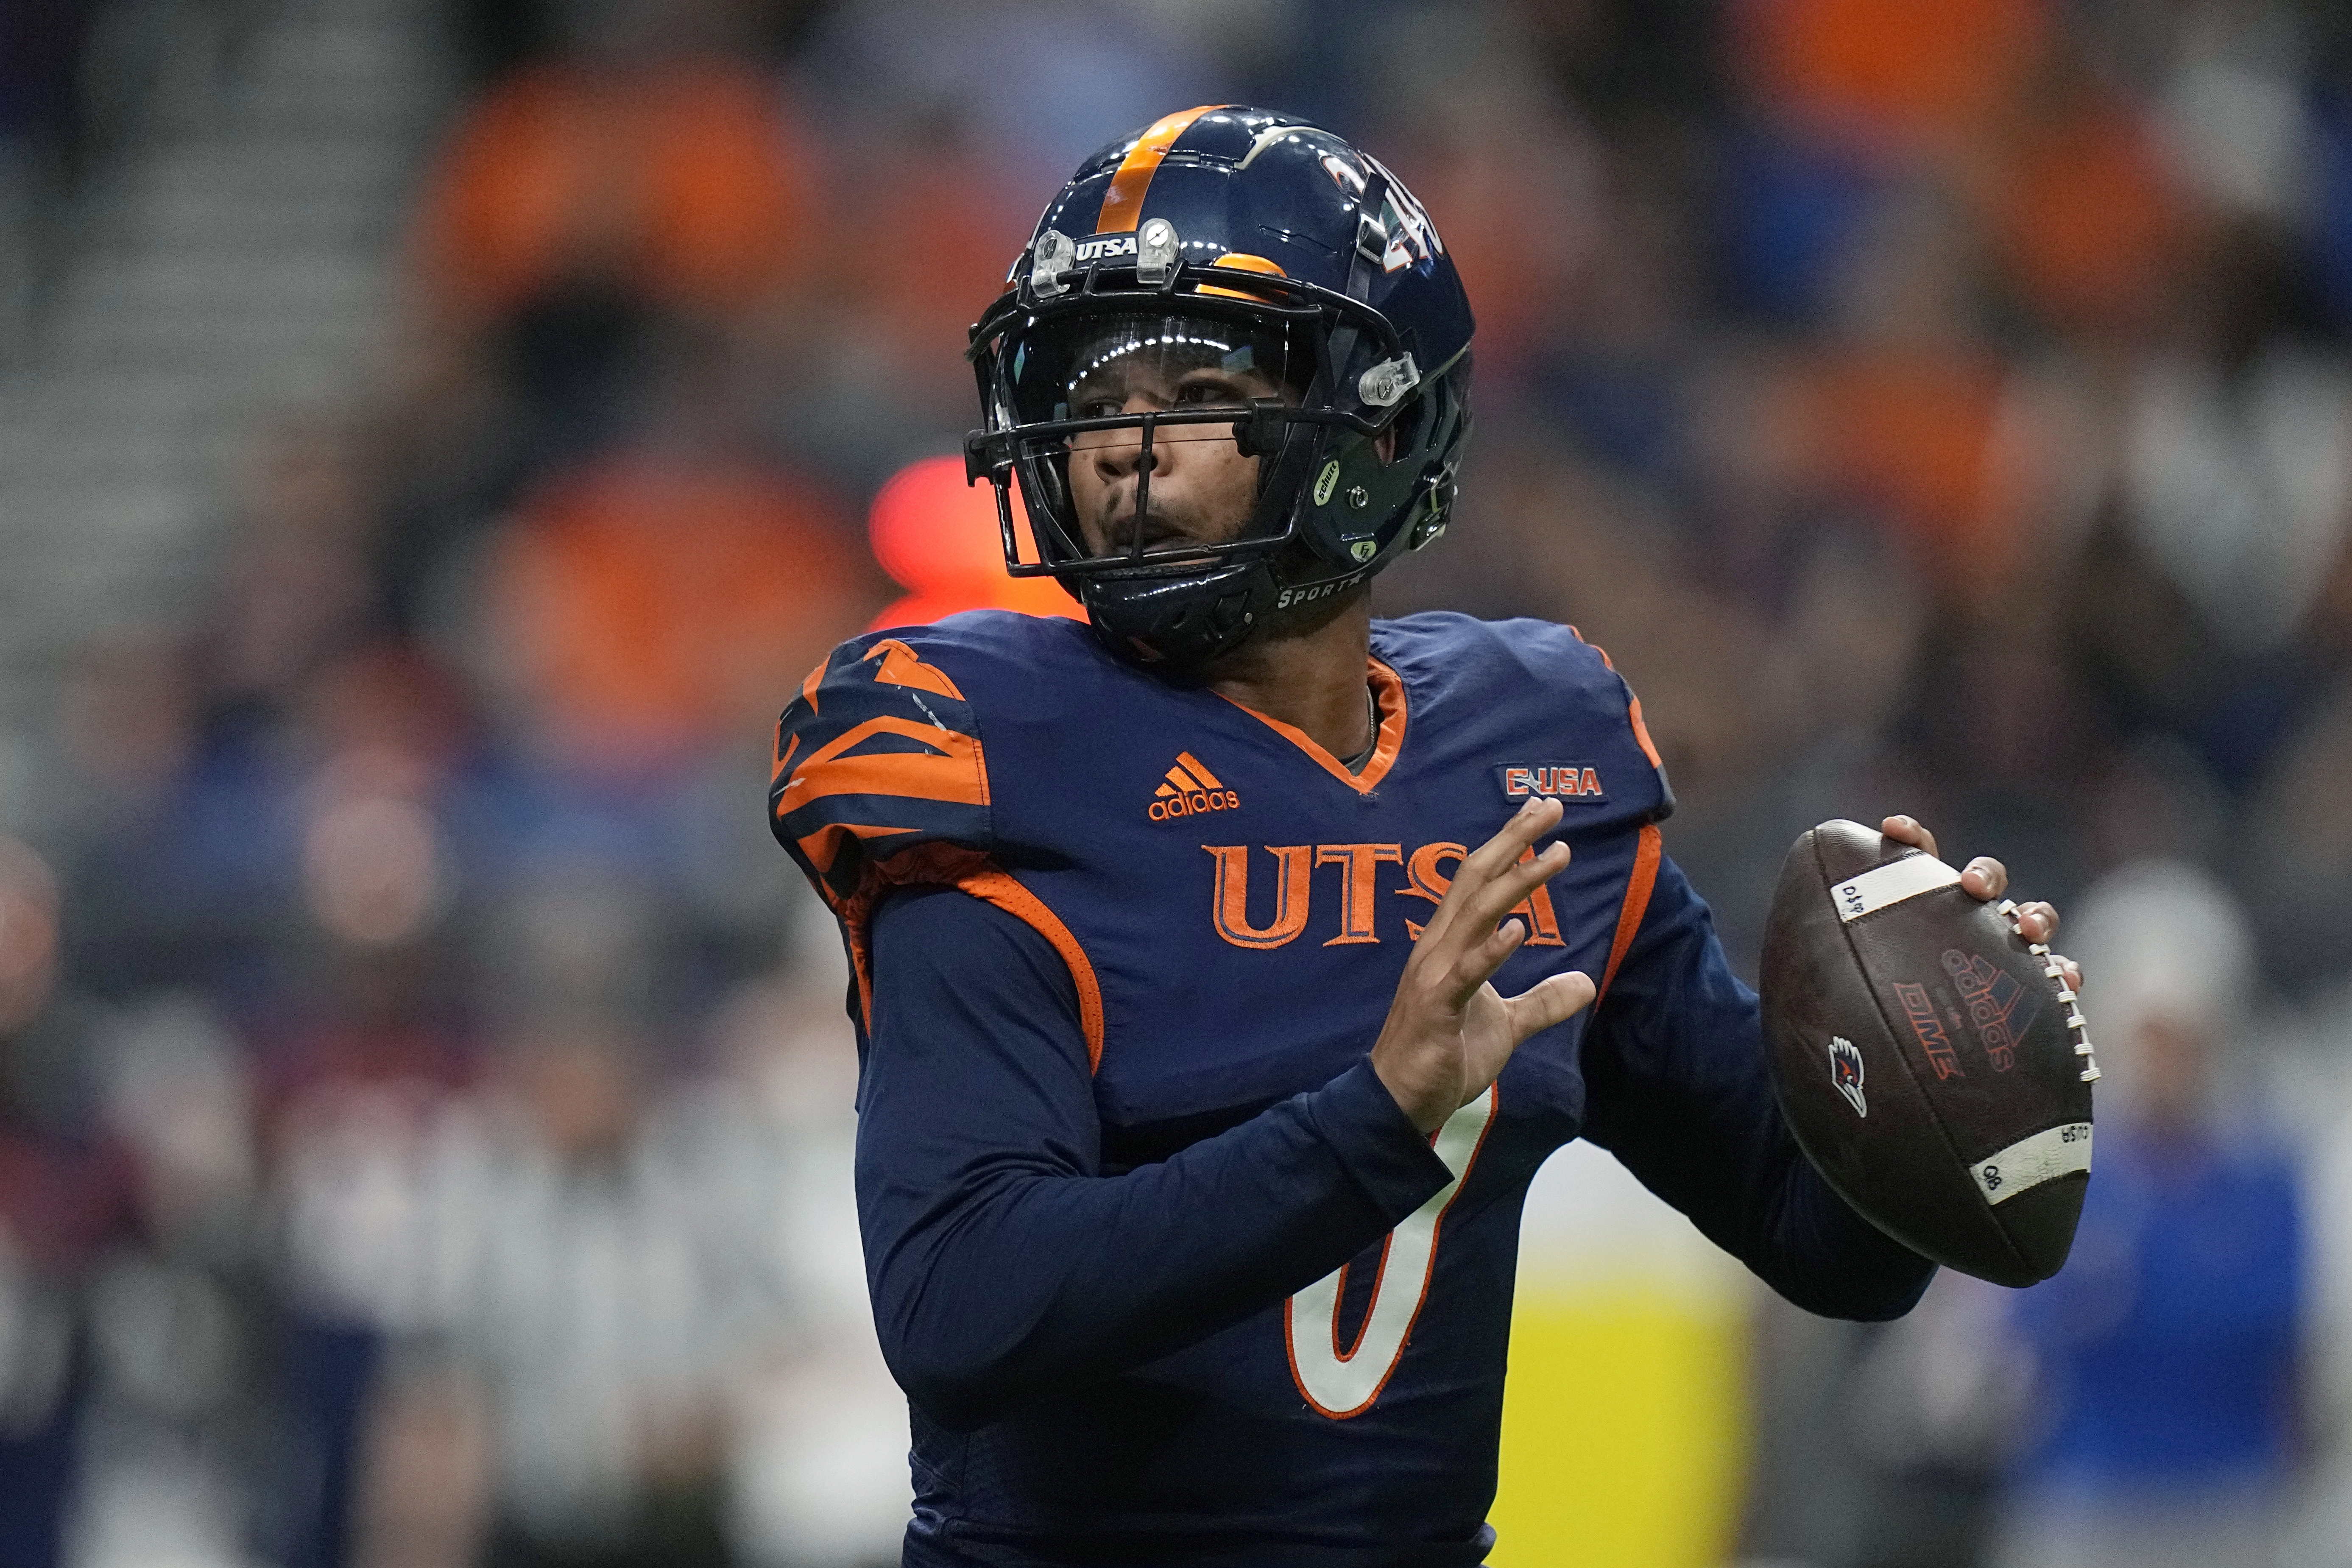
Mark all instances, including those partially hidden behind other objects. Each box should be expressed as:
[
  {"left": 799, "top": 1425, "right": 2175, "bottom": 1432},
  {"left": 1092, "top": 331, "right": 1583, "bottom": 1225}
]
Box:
[{"left": 865, "top": 456, "right": 1087, "bottom": 630}]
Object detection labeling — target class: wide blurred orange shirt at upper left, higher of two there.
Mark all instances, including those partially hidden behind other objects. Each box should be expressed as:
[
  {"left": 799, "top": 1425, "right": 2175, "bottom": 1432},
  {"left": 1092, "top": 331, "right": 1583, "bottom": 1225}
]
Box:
[{"left": 416, "top": 61, "right": 816, "bottom": 317}]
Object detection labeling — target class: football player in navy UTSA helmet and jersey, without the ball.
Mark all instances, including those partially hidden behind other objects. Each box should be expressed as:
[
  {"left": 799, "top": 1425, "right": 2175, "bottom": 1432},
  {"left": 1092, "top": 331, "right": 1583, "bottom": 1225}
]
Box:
[{"left": 769, "top": 106, "right": 2056, "bottom": 1565}]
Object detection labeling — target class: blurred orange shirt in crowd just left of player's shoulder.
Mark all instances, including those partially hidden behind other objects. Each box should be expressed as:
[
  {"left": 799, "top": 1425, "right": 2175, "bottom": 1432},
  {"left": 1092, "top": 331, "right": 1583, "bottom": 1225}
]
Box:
[{"left": 485, "top": 458, "right": 873, "bottom": 769}]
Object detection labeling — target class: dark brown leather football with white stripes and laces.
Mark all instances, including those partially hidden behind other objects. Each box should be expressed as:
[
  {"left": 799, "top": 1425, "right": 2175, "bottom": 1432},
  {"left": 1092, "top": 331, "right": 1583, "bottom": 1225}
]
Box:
[{"left": 1762, "top": 820, "right": 2098, "bottom": 1286}]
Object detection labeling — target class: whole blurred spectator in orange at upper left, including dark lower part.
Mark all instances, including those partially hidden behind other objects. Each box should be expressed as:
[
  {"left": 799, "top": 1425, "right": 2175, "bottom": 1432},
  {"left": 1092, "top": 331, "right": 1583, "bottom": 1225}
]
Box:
[{"left": 405, "top": 0, "right": 828, "bottom": 557}]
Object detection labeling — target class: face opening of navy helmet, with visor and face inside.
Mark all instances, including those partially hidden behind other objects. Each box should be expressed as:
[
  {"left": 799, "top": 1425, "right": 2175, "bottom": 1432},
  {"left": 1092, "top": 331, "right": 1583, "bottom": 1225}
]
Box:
[{"left": 1004, "top": 310, "right": 1315, "bottom": 571}]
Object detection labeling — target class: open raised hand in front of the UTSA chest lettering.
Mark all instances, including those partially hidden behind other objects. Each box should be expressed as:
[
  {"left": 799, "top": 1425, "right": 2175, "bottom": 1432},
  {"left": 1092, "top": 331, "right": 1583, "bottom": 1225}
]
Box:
[{"left": 1371, "top": 797, "right": 1592, "bottom": 1133}]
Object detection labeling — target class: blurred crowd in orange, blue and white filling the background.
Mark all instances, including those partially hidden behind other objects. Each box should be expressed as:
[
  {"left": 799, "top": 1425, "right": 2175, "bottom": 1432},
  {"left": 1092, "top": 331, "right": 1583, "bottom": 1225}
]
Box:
[{"left": 0, "top": 0, "right": 2352, "bottom": 1568}]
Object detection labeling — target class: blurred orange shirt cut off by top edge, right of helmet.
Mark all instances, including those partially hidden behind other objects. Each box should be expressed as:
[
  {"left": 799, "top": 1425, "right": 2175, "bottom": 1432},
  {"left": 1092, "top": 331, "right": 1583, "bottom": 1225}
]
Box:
[{"left": 1738, "top": 0, "right": 2051, "bottom": 143}]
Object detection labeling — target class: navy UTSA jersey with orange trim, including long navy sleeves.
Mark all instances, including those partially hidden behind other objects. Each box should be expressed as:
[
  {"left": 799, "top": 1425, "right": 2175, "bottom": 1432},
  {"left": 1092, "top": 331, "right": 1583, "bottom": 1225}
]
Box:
[{"left": 771, "top": 611, "right": 1929, "bottom": 1563}]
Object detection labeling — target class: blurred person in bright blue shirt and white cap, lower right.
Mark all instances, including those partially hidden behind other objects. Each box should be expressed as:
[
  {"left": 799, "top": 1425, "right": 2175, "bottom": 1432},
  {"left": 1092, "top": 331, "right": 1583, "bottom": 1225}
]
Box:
[{"left": 2001, "top": 863, "right": 2305, "bottom": 1568}]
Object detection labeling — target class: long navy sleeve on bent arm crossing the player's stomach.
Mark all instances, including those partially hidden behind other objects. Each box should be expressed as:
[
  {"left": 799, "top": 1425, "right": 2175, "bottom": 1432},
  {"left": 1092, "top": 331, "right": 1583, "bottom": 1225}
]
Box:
[{"left": 856, "top": 889, "right": 1451, "bottom": 1429}]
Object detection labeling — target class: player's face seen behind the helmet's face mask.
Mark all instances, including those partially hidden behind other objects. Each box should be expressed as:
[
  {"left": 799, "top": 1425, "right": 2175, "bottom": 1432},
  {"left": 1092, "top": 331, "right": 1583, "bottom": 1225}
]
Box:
[{"left": 1068, "top": 322, "right": 1298, "bottom": 555}]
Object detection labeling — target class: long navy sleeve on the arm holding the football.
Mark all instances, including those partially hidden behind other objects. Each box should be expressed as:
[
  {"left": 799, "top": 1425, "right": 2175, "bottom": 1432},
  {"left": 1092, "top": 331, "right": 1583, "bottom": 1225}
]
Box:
[{"left": 1583, "top": 860, "right": 1936, "bottom": 1319}]
